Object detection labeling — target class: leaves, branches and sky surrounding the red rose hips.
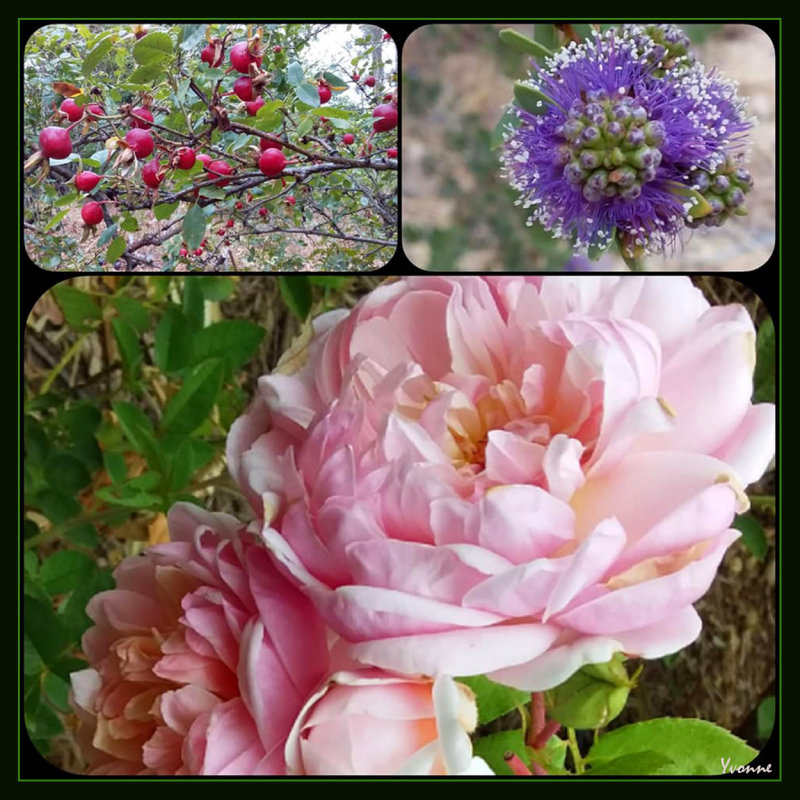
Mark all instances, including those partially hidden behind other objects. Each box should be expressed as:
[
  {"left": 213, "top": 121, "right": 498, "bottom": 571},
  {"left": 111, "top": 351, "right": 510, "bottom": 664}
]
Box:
[{"left": 23, "top": 24, "right": 397, "bottom": 272}]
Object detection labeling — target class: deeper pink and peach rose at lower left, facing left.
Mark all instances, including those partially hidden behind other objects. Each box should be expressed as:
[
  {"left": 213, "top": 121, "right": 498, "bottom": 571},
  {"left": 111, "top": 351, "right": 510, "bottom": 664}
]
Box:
[{"left": 72, "top": 503, "right": 328, "bottom": 775}]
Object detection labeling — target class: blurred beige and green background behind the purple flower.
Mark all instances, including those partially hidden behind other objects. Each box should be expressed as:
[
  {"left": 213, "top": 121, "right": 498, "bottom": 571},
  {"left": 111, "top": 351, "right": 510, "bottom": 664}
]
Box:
[{"left": 401, "top": 23, "right": 775, "bottom": 272}]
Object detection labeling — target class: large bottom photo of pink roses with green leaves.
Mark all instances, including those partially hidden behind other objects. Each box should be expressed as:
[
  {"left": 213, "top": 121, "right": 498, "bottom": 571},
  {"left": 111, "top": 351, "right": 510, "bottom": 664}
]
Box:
[{"left": 20, "top": 274, "right": 780, "bottom": 780}]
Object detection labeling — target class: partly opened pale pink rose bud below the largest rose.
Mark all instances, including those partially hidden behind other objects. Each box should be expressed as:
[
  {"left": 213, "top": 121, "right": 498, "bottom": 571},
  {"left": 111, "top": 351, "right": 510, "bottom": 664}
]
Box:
[{"left": 286, "top": 670, "right": 494, "bottom": 775}]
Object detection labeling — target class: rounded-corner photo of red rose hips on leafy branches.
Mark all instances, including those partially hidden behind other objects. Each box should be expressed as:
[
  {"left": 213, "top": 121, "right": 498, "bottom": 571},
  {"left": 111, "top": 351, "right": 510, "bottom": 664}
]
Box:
[{"left": 23, "top": 23, "right": 398, "bottom": 273}]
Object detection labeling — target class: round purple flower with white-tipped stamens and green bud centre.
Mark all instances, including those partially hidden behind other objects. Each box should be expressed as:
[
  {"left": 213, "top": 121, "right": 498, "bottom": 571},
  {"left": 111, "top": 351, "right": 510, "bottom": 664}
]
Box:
[{"left": 502, "top": 26, "right": 753, "bottom": 253}]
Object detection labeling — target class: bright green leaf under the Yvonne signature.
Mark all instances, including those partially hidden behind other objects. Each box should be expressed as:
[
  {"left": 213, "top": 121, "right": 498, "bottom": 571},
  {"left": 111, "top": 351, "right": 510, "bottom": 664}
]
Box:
[{"left": 586, "top": 718, "right": 758, "bottom": 775}]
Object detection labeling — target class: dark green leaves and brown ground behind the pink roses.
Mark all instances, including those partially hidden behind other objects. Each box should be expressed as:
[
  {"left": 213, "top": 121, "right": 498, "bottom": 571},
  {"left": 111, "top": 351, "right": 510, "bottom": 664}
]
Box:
[{"left": 21, "top": 275, "right": 775, "bottom": 772}]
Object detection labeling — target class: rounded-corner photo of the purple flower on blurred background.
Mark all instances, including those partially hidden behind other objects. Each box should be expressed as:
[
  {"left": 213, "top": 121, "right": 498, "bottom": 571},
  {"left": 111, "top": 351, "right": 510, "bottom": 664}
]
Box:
[{"left": 401, "top": 23, "right": 776, "bottom": 272}]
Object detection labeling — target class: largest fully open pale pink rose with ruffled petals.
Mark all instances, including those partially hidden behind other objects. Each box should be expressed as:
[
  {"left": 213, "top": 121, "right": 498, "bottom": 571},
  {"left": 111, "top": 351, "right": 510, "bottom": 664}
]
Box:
[{"left": 228, "top": 276, "right": 774, "bottom": 690}]
